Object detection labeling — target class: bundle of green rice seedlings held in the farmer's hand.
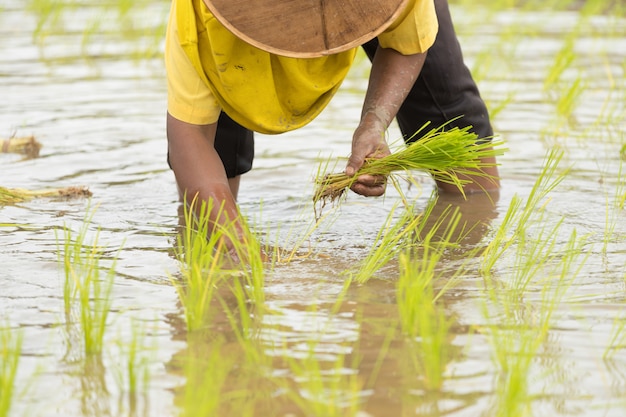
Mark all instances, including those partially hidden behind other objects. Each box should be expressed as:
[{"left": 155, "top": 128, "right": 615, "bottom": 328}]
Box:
[{"left": 313, "top": 125, "right": 504, "bottom": 205}]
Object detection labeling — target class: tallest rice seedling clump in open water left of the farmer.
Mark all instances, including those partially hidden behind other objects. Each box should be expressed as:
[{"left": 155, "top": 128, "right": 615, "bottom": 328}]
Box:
[{"left": 63, "top": 205, "right": 116, "bottom": 355}]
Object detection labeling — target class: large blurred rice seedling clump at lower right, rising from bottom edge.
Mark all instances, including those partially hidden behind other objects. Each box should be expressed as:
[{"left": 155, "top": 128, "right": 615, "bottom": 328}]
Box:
[{"left": 483, "top": 219, "right": 589, "bottom": 416}]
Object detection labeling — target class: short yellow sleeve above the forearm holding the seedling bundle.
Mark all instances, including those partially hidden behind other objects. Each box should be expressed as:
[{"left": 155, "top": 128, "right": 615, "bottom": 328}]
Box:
[{"left": 378, "top": 0, "right": 439, "bottom": 55}]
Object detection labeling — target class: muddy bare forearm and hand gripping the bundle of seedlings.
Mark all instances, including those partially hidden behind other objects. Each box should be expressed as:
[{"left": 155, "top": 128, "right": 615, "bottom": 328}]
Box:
[{"left": 346, "top": 47, "right": 426, "bottom": 196}]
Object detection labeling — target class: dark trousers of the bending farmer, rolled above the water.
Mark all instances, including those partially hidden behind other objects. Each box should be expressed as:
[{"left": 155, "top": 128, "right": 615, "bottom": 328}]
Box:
[{"left": 215, "top": 0, "right": 493, "bottom": 178}]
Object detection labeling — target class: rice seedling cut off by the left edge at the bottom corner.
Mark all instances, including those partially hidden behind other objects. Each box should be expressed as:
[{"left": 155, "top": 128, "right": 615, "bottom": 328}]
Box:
[{"left": 0, "top": 326, "right": 22, "bottom": 417}]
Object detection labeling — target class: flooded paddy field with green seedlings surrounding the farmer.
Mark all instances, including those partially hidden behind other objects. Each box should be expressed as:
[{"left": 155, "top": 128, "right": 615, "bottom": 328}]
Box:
[{"left": 0, "top": 0, "right": 626, "bottom": 417}]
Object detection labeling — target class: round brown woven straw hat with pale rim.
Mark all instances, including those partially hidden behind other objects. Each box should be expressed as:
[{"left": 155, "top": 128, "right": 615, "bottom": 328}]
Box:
[{"left": 205, "top": 0, "right": 409, "bottom": 58}]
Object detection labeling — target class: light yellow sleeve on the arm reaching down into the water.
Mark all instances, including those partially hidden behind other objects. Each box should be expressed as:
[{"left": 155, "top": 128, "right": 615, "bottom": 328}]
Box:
[{"left": 165, "top": 1, "right": 221, "bottom": 125}]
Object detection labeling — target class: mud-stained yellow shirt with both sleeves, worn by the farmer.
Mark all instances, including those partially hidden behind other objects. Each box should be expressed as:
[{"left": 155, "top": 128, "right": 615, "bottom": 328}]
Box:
[{"left": 165, "top": 0, "right": 438, "bottom": 134}]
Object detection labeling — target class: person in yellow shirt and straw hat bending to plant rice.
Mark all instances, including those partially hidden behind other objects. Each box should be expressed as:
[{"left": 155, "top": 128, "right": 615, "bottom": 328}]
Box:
[{"left": 165, "top": 0, "right": 499, "bottom": 247}]
